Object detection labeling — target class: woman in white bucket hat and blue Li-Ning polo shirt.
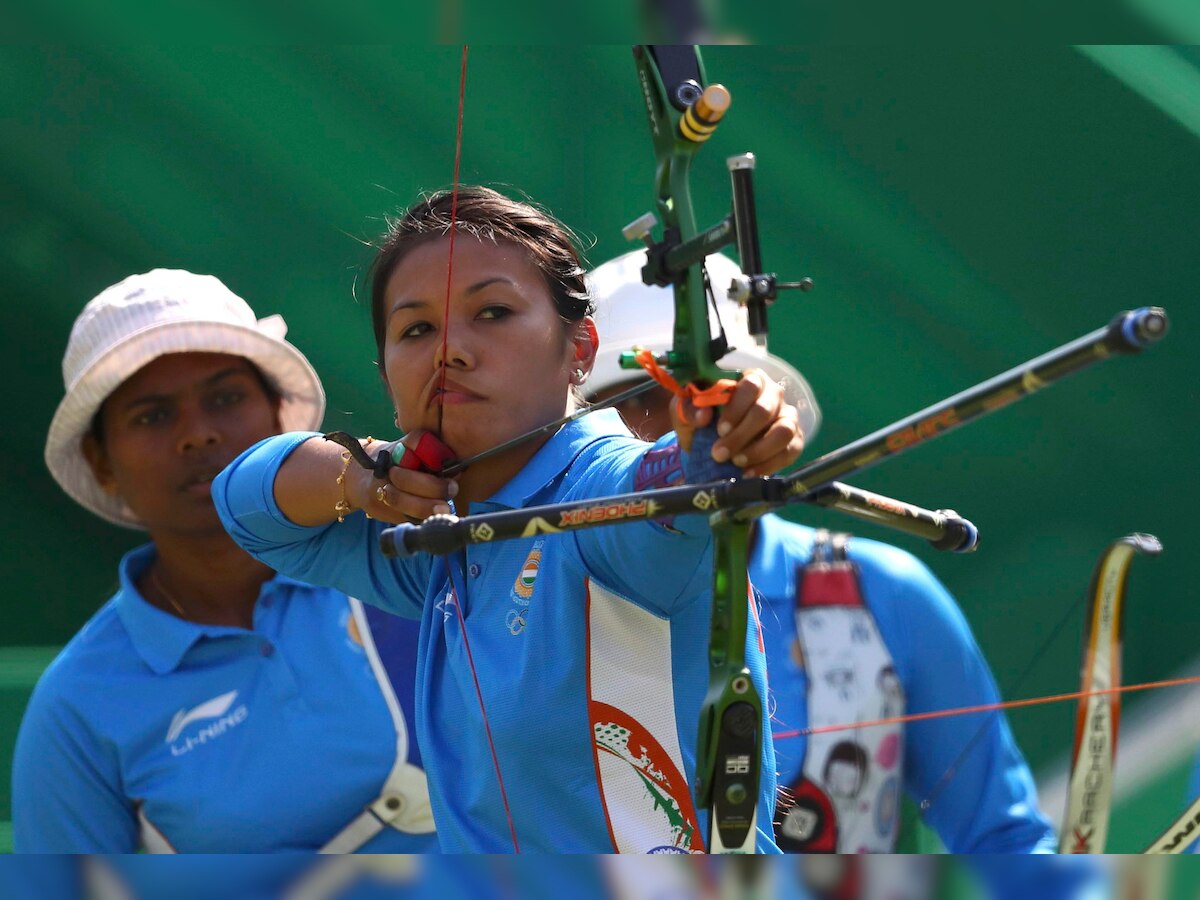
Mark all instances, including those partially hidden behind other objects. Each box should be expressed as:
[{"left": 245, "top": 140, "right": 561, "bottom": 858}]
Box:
[{"left": 13, "top": 269, "right": 437, "bottom": 853}]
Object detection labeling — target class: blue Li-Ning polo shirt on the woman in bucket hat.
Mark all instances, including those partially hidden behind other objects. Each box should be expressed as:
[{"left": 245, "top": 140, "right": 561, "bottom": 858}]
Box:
[{"left": 13, "top": 546, "right": 436, "bottom": 853}]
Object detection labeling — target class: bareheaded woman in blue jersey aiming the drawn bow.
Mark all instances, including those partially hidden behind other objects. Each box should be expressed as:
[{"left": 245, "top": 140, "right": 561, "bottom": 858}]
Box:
[{"left": 214, "top": 186, "right": 803, "bottom": 853}]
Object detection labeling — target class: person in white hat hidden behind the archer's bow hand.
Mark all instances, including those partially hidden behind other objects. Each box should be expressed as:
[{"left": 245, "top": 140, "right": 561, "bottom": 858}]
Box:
[{"left": 588, "top": 251, "right": 1094, "bottom": 896}]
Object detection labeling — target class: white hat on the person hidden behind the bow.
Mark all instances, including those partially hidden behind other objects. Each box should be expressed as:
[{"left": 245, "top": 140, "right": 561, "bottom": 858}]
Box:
[{"left": 586, "top": 250, "right": 821, "bottom": 442}]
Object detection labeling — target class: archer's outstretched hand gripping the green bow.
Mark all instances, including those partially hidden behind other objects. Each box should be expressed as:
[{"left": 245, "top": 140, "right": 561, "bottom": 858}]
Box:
[{"left": 671, "top": 368, "right": 804, "bottom": 478}]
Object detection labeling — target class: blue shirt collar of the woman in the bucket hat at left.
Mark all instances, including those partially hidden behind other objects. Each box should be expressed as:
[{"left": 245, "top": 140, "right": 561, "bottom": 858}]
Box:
[{"left": 115, "top": 544, "right": 304, "bottom": 674}]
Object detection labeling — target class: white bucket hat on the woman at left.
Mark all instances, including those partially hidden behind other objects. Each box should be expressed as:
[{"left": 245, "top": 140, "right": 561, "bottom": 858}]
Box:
[{"left": 46, "top": 269, "right": 325, "bottom": 528}]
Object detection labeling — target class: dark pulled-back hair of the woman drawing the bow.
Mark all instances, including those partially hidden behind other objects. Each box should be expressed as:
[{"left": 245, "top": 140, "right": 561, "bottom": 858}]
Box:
[{"left": 370, "top": 185, "right": 595, "bottom": 370}]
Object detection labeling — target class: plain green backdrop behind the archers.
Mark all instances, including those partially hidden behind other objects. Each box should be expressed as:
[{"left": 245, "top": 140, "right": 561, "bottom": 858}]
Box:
[{"left": 0, "top": 46, "right": 1200, "bottom": 868}]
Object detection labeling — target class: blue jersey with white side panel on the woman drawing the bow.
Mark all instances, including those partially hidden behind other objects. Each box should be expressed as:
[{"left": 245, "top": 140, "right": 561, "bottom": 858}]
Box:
[{"left": 214, "top": 410, "right": 775, "bottom": 853}]
